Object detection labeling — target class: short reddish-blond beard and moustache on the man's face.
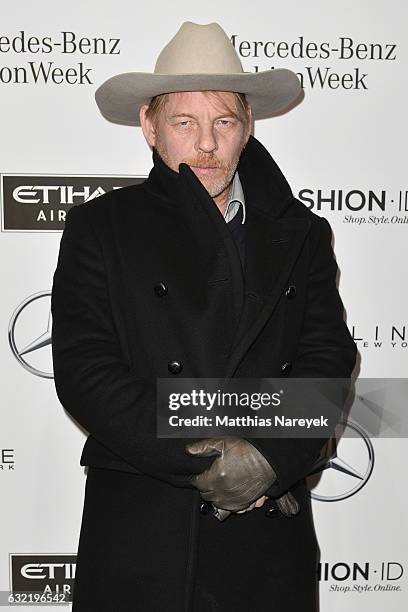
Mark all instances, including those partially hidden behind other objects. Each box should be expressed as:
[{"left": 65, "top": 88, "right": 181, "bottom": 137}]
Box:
[{"left": 155, "top": 138, "right": 245, "bottom": 198}]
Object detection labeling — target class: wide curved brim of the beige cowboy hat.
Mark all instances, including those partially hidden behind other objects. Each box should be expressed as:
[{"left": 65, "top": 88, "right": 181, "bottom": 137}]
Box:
[{"left": 95, "top": 68, "right": 303, "bottom": 126}]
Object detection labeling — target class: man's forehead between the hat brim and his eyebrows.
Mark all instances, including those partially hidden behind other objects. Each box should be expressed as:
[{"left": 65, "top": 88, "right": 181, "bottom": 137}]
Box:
[{"left": 166, "top": 91, "right": 237, "bottom": 115}]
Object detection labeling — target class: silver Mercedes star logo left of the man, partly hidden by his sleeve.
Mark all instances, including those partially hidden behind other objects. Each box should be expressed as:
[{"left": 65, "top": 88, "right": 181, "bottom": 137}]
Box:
[{"left": 8, "top": 291, "right": 54, "bottom": 378}]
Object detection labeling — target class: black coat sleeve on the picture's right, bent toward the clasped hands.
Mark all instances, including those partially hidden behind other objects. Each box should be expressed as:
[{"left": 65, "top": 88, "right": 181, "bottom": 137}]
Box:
[{"left": 250, "top": 217, "right": 357, "bottom": 497}]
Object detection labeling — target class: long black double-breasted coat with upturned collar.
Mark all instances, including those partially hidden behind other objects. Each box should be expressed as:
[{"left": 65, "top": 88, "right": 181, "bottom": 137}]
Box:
[{"left": 52, "top": 136, "right": 356, "bottom": 612}]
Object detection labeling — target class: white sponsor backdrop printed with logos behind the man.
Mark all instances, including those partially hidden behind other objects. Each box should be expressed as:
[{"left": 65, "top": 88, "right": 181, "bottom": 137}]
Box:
[{"left": 0, "top": 0, "right": 408, "bottom": 612}]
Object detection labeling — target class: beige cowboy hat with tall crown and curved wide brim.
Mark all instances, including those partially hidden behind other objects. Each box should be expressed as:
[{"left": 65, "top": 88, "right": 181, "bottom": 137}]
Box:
[{"left": 95, "top": 21, "right": 302, "bottom": 126}]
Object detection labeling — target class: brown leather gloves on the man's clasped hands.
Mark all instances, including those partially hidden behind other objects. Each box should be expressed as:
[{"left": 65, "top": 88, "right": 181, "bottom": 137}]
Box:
[{"left": 186, "top": 437, "right": 300, "bottom": 521}]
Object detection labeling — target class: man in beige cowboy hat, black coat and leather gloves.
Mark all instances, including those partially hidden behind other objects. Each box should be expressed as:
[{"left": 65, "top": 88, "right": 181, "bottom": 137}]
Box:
[{"left": 52, "top": 22, "right": 356, "bottom": 612}]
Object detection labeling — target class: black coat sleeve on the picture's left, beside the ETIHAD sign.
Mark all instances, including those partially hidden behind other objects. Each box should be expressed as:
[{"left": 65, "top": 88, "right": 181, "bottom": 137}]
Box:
[{"left": 51, "top": 204, "right": 212, "bottom": 487}]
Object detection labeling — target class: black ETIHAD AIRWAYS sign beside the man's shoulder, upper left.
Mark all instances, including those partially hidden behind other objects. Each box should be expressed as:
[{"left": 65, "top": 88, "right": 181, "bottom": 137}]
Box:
[{"left": 0, "top": 174, "right": 146, "bottom": 232}]
